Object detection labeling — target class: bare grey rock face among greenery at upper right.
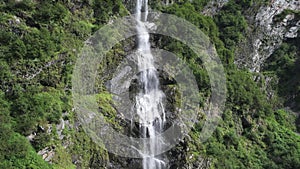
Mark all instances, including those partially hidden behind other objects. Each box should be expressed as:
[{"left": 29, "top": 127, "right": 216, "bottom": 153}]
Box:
[{"left": 235, "top": 0, "right": 300, "bottom": 72}]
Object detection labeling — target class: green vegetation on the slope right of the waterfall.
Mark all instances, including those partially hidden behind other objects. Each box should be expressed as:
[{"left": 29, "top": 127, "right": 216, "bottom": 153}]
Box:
[{"left": 158, "top": 1, "right": 300, "bottom": 169}]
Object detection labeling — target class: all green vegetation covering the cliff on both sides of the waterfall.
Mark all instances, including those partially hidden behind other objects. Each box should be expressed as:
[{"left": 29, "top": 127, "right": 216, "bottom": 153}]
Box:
[{"left": 0, "top": 0, "right": 300, "bottom": 169}]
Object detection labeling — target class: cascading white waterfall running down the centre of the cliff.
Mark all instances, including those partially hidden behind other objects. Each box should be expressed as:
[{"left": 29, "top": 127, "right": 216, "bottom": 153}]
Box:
[{"left": 135, "top": 0, "right": 165, "bottom": 169}]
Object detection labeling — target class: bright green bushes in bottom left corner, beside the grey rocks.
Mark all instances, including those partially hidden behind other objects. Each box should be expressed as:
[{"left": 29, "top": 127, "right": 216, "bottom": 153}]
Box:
[{"left": 0, "top": 92, "right": 51, "bottom": 169}]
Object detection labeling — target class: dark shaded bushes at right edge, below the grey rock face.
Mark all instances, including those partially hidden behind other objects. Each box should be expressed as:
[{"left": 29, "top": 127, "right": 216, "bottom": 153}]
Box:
[{"left": 265, "top": 38, "right": 300, "bottom": 110}]
